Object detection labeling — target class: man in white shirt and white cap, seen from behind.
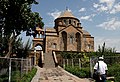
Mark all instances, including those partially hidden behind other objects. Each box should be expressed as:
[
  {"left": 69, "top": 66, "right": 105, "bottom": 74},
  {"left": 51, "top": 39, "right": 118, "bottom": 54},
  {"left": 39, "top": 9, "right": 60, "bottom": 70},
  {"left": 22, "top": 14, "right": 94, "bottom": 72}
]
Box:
[{"left": 94, "top": 57, "right": 108, "bottom": 82}]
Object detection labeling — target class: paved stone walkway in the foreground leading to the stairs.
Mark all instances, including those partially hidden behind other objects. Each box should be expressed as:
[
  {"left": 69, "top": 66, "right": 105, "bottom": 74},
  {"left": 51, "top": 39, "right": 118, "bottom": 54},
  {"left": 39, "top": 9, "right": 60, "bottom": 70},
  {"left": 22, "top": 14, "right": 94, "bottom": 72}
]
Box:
[{"left": 31, "top": 66, "right": 94, "bottom": 82}]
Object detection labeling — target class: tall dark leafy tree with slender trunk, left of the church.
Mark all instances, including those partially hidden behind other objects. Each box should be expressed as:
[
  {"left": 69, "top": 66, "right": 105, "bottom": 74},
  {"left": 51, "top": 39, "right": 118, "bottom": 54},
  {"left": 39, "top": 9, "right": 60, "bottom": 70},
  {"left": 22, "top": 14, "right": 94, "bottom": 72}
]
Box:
[{"left": 0, "top": 0, "right": 44, "bottom": 57}]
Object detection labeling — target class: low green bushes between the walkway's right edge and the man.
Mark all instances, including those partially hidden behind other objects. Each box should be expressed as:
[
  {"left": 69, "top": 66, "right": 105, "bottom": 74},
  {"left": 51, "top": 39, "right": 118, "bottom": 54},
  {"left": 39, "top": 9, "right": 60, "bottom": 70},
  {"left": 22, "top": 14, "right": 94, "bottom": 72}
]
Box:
[{"left": 65, "top": 66, "right": 90, "bottom": 78}]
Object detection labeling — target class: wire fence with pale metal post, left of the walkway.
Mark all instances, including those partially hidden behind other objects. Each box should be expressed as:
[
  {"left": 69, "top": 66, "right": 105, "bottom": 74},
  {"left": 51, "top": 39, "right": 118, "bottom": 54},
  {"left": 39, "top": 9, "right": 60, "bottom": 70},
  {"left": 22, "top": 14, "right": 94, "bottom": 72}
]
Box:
[{"left": 0, "top": 57, "right": 34, "bottom": 82}]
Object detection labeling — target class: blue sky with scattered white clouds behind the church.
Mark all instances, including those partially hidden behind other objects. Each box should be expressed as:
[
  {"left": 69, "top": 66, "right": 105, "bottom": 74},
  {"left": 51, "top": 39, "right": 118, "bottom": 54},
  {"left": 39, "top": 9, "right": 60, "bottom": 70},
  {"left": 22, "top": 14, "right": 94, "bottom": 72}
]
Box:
[{"left": 22, "top": 0, "right": 120, "bottom": 51}]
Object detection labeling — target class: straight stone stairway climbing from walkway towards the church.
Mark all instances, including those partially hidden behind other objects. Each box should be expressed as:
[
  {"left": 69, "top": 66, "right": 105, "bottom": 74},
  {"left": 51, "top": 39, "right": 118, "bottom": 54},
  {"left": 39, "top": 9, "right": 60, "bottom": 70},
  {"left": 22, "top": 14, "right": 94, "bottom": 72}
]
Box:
[{"left": 43, "top": 52, "right": 55, "bottom": 68}]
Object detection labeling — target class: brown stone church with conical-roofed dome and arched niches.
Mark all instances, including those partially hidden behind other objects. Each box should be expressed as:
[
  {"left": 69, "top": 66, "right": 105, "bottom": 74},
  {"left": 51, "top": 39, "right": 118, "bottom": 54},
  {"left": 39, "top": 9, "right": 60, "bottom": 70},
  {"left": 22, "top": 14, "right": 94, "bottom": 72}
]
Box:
[{"left": 33, "top": 10, "right": 94, "bottom": 53}]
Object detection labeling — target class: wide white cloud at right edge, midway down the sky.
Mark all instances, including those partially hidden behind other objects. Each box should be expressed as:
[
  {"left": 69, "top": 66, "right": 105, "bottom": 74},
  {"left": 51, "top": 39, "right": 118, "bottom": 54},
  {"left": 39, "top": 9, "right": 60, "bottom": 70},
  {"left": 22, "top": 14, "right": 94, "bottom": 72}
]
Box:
[{"left": 97, "top": 18, "right": 120, "bottom": 30}]
